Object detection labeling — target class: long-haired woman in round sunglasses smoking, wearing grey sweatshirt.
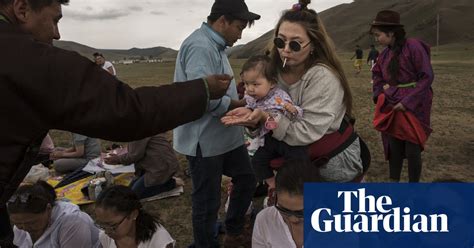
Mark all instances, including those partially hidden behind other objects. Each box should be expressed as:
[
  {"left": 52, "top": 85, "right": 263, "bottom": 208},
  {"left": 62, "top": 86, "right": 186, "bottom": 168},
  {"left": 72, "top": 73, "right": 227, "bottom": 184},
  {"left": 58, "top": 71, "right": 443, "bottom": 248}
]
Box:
[{"left": 223, "top": 1, "right": 363, "bottom": 182}]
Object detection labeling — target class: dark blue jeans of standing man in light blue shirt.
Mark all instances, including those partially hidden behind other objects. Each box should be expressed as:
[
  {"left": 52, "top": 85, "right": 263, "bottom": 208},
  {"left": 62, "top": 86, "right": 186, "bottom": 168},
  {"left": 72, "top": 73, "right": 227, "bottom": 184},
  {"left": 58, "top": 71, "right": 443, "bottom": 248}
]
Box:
[{"left": 187, "top": 145, "right": 256, "bottom": 248}]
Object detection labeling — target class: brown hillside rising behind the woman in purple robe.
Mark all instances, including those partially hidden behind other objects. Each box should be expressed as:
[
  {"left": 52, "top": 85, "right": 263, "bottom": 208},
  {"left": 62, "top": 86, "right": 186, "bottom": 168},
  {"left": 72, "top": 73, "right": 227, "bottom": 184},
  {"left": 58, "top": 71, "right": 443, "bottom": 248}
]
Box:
[{"left": 230, "top": 0, "right": 474, "bottom": 58}]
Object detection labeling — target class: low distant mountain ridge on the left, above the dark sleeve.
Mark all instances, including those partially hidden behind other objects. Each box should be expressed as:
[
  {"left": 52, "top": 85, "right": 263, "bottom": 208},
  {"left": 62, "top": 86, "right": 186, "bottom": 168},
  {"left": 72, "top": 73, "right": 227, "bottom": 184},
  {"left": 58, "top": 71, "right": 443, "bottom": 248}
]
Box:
[{"left": 54, "top": 41, "right": 178, "bottom": 60}]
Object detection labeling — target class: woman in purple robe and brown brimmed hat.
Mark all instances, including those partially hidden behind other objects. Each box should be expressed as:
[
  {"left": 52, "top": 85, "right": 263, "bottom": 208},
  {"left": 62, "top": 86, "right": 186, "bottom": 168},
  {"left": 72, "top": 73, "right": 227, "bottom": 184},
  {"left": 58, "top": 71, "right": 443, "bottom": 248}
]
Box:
[{"left": 370, "top": 10, "right": 434, "bottom": 182}]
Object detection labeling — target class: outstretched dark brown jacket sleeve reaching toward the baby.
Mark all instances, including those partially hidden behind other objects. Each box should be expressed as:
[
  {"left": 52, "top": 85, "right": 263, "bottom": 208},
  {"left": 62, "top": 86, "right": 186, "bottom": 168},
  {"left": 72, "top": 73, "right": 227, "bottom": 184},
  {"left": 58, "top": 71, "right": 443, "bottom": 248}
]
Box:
[{"left": 23, "top": 44, "right": 209, "bottom": 141}]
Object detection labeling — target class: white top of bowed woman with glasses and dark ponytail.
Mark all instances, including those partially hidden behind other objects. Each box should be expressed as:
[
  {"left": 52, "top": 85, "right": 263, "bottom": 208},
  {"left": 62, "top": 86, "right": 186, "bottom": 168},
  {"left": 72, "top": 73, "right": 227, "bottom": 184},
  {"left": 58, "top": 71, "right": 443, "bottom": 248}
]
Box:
[{"left": 99, "top": 226, "right": 176, "bottom": 248}]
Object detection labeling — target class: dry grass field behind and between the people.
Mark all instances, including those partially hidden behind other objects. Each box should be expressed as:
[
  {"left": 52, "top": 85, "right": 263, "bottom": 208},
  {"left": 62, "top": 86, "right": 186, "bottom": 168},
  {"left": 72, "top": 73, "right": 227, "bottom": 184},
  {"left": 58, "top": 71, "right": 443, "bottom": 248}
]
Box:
[{"left": 52, "top": 44, "right": 474, "bottom": 247}]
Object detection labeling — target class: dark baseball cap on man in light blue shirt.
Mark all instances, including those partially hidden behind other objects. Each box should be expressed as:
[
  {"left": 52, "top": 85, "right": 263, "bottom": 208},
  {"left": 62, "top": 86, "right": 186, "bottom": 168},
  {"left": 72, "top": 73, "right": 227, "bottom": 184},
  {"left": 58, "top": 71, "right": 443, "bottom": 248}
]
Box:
[{"left": 211, "top": 0, "right": 260, "bottom": 21}]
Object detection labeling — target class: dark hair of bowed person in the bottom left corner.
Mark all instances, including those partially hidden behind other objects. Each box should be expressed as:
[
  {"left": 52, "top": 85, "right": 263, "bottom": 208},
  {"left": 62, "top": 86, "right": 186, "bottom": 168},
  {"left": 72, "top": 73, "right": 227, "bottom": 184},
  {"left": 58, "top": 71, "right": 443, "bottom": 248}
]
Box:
[{"left": 7, "top": 181, "right": 56, "bottom": 214}]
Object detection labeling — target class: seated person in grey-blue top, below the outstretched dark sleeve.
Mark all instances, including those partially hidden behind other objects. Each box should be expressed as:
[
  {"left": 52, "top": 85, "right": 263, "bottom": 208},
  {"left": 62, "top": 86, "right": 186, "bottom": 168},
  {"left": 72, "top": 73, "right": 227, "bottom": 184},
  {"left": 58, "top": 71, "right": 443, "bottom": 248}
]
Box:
[{"left": 49, "top": 133, "right": 100, "bottom": 174}]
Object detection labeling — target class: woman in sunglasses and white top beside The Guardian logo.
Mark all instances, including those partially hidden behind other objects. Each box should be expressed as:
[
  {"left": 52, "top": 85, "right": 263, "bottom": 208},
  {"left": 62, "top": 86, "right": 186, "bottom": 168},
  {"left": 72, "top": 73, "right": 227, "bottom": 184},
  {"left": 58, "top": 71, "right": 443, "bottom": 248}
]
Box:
[{"left": 252, "top": 160, "right": 320, "bottom": 248}]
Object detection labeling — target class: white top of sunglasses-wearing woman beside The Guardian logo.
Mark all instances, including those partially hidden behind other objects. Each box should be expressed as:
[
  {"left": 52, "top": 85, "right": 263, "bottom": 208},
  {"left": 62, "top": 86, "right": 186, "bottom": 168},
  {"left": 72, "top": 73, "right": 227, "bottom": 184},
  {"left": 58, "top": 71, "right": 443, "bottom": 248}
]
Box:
[{"left": 252, "top": 207, "right": 296, "bottom": 248}]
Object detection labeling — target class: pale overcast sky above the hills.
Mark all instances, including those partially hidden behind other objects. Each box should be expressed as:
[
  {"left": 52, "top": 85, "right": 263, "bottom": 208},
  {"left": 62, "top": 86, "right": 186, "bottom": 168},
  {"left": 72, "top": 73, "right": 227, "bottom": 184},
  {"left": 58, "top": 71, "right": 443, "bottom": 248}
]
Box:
[{"left": 59, "top": 0, "right": 352, "bottom": 49}]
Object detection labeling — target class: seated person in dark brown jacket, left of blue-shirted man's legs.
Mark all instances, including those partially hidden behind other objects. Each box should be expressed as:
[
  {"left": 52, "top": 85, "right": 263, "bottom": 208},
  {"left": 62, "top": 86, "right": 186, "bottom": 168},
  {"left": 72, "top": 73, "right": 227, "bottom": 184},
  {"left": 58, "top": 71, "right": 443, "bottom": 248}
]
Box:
[{"left": 104, "top": 133, "right": 179, "bottom": 199}]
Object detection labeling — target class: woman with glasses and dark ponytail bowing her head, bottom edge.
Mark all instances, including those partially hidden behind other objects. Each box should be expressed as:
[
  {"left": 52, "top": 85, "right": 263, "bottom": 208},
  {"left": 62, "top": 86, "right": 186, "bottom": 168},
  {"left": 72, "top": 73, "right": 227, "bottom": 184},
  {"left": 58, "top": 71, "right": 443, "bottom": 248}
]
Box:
[{"left": 95, "top": 185, "right": 175, "bottom": 248}]
